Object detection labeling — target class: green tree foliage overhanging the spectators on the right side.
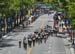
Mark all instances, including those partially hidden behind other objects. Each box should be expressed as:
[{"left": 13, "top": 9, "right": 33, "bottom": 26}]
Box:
[{"left": 45, "top": 0, "right": 75, "bottom": 27}]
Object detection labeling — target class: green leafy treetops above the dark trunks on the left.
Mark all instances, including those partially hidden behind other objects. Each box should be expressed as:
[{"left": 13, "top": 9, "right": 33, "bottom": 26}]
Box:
[{"left": 0, "top": 0, "right": 36, "bottom": 16}]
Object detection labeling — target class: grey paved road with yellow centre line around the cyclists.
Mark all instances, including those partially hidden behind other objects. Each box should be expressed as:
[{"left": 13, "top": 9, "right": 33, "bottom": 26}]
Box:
[{"left": 0, "top": 14, "right": 71, "bottom": 54}]
